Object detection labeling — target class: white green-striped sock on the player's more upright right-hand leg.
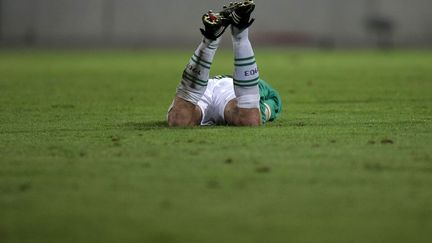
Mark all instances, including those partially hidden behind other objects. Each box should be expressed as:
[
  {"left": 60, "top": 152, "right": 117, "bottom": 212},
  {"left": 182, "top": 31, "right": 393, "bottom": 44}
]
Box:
[{"left": 231, "top": 26, "right": 260, "bottom": 109}]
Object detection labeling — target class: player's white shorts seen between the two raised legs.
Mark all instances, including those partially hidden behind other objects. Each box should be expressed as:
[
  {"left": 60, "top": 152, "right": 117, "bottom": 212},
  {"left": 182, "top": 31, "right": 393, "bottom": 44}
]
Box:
[{"left": 198, "top": 77, "right": 236, "bottom": 126}]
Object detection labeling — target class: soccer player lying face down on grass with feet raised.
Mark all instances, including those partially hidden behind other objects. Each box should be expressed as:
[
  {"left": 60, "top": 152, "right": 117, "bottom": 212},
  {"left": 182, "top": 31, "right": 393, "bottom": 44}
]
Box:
[{"left": 168, "top": 1, "right": 282, "bottom": 127}]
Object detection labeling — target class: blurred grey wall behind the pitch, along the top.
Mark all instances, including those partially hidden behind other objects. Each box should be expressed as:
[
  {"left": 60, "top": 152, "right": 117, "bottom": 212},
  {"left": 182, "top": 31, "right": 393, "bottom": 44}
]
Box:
[{"left": 0, "top": 0, "right": 432, "bottom": 48}]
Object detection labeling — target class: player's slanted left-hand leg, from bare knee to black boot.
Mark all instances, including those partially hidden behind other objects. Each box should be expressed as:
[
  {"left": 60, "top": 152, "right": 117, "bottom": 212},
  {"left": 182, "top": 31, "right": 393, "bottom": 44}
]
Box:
[{"left": 168, "top": 11, "right": 230, "bottom": 126}]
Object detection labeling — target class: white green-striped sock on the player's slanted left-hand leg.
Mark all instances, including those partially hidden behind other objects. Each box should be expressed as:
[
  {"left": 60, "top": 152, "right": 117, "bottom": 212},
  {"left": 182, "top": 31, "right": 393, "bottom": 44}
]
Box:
[{"left": 177, "top": 38, "right": 220, "bottom": 105}]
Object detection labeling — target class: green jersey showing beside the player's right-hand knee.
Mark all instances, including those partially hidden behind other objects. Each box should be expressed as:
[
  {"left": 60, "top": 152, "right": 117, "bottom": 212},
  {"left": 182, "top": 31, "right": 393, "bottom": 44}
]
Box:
[{"left": 258, "top": 79, "right": 282, "bottom": 123}]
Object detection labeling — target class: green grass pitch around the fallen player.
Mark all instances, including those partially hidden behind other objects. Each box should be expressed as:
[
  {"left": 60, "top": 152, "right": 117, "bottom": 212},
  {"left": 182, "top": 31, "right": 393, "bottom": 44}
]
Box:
[{"left": 0, "top": 48, "right": 432, "bottom": 243}]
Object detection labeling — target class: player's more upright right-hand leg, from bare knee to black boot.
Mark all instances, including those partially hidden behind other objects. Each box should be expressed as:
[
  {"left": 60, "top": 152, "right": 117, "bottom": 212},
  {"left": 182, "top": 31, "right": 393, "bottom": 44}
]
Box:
[{"left": 225, "top": 1, "right": 261, "bottom": 126}]
